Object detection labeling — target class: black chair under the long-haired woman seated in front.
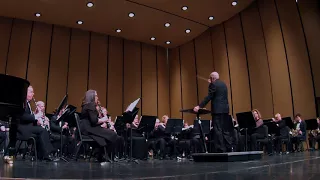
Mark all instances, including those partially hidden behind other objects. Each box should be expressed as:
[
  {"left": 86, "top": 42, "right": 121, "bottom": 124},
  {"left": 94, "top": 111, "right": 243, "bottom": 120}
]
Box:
[{"left": 74, "top": 113, "right": 107, "bottom": 160}]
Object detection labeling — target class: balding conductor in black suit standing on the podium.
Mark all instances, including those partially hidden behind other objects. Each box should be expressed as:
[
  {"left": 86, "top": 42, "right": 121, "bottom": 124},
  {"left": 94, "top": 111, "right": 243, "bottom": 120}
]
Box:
[{"left": 193, "top": 72, "right": 232, "bottom": 152}]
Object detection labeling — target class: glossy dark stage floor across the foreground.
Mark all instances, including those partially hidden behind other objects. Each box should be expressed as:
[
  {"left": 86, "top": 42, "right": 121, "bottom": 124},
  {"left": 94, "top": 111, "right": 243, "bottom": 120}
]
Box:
[{"left": 0, "top": 151, "right": 320, "bottom": 180}]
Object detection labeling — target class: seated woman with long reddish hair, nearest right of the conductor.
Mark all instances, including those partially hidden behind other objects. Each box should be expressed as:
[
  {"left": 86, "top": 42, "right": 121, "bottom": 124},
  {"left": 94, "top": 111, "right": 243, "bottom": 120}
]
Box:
[{"left": 250, "top": 109, "right": 266, "bottom": 151}]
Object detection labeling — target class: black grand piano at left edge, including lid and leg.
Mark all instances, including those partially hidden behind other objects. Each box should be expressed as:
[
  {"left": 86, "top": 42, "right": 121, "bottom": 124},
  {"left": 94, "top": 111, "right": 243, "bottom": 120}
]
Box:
[{"left": 0, "top": 74, "right": 30, "bottom": 162}]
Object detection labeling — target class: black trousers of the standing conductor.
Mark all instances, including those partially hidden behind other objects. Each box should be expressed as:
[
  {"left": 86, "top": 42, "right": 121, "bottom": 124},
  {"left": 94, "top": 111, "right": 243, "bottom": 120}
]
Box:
[{"left": 212, "top": 113, "right": 233, "bottom": 152}]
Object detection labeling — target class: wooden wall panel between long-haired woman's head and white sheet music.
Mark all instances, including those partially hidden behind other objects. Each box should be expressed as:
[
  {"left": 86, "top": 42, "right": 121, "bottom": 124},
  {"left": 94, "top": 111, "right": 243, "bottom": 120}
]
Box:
[{"left": 107, "top": 37, "right": 123, "bottom": 117}]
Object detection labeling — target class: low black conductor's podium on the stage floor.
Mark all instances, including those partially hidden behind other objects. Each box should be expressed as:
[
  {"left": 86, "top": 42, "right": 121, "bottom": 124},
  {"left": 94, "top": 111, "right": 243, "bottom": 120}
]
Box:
[{"left": 192, "top": 151, "right": 263, "bottom": 162}]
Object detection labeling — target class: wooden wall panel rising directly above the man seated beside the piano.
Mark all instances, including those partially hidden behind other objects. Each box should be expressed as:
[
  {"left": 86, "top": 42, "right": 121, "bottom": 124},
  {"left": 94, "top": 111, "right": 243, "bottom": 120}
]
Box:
[{"left": 27, "top": 22, "right": 53, "bottom": 103}]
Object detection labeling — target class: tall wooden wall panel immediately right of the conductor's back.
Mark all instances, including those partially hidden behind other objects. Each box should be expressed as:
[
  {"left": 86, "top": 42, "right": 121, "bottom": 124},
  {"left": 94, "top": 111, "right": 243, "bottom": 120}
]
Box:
[{"left": 225, "top": 15, "right": 252, "bottom": 113}]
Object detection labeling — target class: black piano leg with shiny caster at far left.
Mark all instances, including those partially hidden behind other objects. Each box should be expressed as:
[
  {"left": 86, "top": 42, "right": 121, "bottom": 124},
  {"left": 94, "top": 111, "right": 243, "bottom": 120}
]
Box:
[{"left": 4, "top": 117, "right": 18, "bottom": 164}]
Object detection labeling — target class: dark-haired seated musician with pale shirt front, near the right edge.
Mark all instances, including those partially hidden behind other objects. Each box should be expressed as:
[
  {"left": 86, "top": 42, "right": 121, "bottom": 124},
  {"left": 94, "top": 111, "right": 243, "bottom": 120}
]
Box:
[{"left": 291, "top": 113, "right": 307, "bottom": 152}]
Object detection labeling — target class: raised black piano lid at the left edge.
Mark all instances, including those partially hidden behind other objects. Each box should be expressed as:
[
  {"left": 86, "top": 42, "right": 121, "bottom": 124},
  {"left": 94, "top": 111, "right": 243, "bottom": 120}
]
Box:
[{"left": 0, "top": 74, "right": 30, "bottom": 120}]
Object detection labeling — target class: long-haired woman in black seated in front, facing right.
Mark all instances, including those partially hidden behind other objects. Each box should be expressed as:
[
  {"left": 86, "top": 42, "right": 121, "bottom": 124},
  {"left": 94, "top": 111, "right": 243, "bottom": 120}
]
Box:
[{"left": 80, "top": 90, "right": 118, "bottom": 162}]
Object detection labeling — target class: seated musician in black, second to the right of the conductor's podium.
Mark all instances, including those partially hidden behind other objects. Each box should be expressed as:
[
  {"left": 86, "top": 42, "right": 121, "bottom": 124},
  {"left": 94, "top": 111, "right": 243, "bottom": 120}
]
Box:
[{"left": 272, "top": 113, "right": 290, "bottom": 154}]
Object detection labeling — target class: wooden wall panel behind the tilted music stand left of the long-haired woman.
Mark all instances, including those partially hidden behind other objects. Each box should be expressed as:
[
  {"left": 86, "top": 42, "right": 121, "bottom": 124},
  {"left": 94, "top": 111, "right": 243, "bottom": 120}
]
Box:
[{"left": 47, "top": 26, "right": 70, "bottom": 113}]
